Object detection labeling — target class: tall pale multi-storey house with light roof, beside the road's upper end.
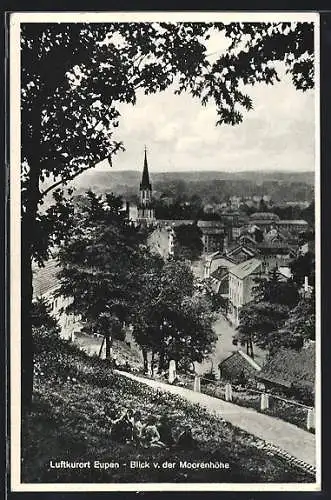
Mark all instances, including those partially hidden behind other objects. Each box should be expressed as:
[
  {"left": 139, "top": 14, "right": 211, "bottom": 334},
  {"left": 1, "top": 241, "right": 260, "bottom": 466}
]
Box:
[{"left": 228, "top": 258, "right": 264, "bottom": 326}]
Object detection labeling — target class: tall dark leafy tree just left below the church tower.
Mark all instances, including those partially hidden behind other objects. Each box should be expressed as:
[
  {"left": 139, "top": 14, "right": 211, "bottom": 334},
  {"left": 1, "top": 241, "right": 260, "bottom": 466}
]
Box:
[{"left": 58, "top": 192, "right": 142, "bottom": 337}]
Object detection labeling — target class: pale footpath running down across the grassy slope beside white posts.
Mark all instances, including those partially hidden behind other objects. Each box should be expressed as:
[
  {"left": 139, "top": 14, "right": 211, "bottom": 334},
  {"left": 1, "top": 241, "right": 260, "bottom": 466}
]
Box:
[{"left": 118, "top": 372, "right": 316, "bottom": 466}]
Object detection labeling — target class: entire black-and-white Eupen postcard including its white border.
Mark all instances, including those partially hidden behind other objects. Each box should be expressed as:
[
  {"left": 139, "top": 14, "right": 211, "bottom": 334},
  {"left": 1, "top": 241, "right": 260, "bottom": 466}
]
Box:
[{"left": 9, "top": 12, "right": 321, "bottom": 492}]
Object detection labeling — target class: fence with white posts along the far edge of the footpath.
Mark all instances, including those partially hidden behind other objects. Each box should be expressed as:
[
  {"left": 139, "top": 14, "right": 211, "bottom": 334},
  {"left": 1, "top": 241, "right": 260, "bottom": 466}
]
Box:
[{"left": 175, "top": 374, "right": 315, "bottom": 432}]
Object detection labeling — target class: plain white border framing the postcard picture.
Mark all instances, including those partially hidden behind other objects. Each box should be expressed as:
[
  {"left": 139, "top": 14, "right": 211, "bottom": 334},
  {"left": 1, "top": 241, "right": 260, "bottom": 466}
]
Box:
[{"left": 9, "top": 11, "right": 321, "bottom": 492}]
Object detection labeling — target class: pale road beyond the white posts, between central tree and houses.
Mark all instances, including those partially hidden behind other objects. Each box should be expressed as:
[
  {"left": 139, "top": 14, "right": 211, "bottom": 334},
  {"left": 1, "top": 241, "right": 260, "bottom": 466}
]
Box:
[{"left": 196, "top": 315, "right": 266, "bottom": 374}]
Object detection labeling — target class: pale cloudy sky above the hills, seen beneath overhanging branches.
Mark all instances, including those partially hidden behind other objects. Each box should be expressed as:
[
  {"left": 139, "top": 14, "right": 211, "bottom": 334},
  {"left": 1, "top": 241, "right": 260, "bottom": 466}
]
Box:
[{"left": 97, "top": 28, "right": 315, "bottom": 176}]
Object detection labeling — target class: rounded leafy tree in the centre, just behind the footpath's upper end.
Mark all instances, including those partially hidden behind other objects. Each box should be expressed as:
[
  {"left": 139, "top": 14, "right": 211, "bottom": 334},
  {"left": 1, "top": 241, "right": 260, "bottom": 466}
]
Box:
[{"left": 132, "top": 261, "right": 216, "bottom": 369}]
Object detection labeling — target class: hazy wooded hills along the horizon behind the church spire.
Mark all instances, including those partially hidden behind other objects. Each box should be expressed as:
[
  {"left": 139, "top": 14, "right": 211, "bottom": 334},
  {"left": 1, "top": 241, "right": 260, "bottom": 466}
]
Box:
[{"left": 74, "top": 169, "right": 314, "bottom": 203}]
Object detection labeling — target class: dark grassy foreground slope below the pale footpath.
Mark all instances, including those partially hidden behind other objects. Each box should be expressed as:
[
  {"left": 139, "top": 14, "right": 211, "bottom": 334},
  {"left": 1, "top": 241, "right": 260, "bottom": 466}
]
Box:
[{"left": 22, "top": 334, "right": 312, "bottom": 483}]
